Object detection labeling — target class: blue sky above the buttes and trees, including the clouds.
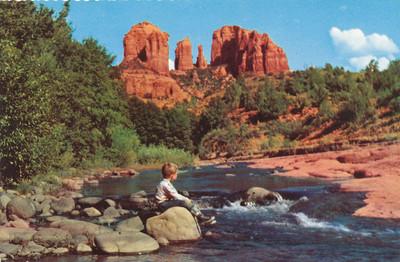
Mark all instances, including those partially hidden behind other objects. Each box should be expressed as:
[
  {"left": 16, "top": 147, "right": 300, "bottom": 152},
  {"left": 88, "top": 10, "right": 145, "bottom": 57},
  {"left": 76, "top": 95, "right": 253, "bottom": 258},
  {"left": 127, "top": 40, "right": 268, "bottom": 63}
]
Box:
[{"left": 41, "top": 0, "right": 400, "bottom": 70}]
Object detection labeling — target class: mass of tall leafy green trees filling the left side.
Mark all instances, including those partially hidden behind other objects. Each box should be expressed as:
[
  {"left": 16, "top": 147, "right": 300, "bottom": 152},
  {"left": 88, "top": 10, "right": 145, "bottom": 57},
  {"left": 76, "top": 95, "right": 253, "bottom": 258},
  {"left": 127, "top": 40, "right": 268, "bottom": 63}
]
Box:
[{"left": 0, "top": 2, "right": 132, "bottom": 182}]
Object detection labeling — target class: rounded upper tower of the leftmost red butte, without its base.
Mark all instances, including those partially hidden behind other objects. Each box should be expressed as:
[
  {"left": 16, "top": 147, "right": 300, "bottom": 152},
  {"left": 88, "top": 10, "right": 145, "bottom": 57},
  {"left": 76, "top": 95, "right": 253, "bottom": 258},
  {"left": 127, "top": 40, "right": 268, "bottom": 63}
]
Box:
[{"left": 122, "top": 22, "right": 169, "bottom": 75}]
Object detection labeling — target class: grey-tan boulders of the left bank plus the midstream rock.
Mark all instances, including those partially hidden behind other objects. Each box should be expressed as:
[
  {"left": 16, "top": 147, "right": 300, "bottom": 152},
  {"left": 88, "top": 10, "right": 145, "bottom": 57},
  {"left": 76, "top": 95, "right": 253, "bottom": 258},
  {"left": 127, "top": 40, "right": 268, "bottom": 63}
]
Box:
[{"left": 0, "top": 166, "right": 281, "bottom": 259}]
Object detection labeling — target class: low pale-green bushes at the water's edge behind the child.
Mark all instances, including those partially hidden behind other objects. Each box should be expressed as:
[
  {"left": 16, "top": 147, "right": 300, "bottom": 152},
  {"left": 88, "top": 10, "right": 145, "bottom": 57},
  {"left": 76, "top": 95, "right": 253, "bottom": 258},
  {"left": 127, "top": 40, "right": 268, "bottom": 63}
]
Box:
[{"left": 137, "top": 145, "right": 194, "bottom": 165}]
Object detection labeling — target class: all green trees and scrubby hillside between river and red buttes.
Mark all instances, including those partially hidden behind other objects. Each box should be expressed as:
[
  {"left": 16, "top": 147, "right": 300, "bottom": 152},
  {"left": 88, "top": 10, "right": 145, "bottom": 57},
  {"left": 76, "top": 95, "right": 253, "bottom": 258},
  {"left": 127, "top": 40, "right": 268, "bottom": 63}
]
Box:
[{"left": 0, "top": 2, "right": 400, "bottom": 186}]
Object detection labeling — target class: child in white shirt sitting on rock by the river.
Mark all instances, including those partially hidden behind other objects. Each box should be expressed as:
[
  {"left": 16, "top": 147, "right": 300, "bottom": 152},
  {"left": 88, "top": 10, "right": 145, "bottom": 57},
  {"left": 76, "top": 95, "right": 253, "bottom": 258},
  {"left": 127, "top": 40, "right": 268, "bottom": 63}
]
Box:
[{"left": 155, "top": 163, "right": 216, "bottom": 225}]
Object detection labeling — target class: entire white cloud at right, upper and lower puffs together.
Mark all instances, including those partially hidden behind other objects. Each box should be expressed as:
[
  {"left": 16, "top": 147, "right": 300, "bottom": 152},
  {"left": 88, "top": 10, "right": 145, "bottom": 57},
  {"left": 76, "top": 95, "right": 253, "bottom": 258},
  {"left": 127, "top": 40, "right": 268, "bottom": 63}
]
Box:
[{"left": 329, "top": 27, "right": 399, "bottom": 70}]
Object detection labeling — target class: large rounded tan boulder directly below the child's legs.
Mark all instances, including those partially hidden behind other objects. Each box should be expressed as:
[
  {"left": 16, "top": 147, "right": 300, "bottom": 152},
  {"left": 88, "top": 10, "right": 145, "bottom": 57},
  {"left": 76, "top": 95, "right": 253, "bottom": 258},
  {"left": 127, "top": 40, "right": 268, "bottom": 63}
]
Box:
[{"left": 146, "top": 207, "right": 201, "bottom": 241}]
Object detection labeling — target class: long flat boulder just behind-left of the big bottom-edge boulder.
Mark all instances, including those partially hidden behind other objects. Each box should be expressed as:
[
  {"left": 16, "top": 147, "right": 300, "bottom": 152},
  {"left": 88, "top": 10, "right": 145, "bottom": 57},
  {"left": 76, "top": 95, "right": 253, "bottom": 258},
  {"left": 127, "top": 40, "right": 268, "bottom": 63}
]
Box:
[{"left": 50, "top": 219, "right": 113, "bottom": 239}]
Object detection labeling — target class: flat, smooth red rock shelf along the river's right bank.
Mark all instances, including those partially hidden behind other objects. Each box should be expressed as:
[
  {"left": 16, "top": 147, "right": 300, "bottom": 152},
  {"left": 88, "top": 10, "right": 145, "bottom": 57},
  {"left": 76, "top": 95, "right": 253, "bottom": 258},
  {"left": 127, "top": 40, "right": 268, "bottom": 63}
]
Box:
[{"left": 247, "top": 144, "right": 400, "bottom": 219}]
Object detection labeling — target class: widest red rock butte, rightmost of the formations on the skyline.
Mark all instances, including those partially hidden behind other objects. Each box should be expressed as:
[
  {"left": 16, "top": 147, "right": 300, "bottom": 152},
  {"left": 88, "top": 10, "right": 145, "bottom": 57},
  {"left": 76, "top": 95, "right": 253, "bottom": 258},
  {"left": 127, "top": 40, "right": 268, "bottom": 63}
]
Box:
[{"left": 211, "top": 26, "right": 289, "bottom": 75}]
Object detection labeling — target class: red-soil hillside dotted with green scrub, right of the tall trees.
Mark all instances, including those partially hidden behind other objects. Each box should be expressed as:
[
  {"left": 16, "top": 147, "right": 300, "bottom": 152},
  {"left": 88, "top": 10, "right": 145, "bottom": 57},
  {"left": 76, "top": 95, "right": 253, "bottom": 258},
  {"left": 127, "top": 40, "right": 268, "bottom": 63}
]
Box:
[{"left": 129, "top": 61, "right": 400, "bottom": 158}]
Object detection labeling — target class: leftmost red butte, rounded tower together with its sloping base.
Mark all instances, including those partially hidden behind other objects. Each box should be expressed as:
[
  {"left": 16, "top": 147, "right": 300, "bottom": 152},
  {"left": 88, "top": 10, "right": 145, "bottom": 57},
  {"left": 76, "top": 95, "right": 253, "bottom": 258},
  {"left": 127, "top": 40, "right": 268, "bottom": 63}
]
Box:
[{"left": 119, "top": 22, "right": 193, "bottom": 107}]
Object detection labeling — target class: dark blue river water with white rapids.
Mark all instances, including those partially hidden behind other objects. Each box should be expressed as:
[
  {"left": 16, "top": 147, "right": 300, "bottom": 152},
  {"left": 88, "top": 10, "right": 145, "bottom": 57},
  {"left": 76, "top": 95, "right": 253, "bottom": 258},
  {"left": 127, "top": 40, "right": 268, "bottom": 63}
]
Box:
[{"left": 41, "top": 165, "right": 400, "bottom": 262}]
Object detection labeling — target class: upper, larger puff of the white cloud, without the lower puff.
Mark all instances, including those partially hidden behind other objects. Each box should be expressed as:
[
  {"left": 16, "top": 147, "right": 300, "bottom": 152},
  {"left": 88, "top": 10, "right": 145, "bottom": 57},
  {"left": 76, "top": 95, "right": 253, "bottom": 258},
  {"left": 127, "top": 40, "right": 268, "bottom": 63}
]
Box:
[{"left": 329, "top": 27, "right": 399, "bottom": 55}]
